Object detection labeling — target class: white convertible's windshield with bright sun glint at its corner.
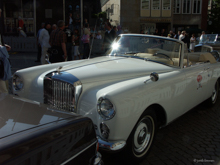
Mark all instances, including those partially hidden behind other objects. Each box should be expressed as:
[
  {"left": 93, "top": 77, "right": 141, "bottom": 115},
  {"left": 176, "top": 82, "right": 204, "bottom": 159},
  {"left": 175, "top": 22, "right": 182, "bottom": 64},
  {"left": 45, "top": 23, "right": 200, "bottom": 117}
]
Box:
[{"left": 106, "top": 35, "right": 181, "bottom": 67}]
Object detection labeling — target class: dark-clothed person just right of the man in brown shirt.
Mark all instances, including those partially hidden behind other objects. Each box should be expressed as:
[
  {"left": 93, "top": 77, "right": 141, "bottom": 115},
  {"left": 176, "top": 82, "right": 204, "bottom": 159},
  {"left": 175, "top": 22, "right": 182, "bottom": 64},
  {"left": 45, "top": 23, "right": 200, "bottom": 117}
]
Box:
[{"left": 63, "top": 22, "right": 74, "bottom": 61}]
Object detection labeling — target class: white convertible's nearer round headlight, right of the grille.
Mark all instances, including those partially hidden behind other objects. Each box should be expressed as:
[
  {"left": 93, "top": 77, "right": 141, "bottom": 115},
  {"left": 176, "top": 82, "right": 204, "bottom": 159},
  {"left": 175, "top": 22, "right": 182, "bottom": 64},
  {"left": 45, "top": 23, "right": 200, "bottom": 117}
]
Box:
[{"left": 97, "top": 97, "right": 116, "bottom": 120}]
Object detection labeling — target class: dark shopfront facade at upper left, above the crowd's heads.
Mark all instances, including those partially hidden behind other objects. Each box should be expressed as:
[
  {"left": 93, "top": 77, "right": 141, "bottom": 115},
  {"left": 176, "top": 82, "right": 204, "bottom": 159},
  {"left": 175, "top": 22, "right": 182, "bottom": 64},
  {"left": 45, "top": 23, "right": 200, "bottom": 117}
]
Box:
[{"left": 0, "top": 0, "right": 101, "bottom": 36}]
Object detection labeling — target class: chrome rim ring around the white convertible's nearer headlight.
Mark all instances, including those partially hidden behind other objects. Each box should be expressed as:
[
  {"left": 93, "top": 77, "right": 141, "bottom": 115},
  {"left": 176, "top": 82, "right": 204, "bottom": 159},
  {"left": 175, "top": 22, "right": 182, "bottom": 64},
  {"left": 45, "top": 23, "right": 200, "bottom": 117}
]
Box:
[{"left": 97, "top": 97, "right": 116, "bottom": 120}]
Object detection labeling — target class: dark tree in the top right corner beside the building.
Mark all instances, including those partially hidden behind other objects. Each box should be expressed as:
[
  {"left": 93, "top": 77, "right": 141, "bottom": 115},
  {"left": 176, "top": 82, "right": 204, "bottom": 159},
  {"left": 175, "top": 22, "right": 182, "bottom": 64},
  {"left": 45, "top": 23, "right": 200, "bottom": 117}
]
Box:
[{"left": 208, "top": 0, "right": 220, "bottom": 34}]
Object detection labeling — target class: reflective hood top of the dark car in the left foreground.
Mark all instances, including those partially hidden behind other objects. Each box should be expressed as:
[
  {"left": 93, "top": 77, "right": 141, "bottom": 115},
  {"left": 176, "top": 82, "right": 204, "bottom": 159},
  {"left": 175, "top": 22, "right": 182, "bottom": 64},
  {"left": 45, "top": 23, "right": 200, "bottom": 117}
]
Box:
[{"left": 0, "top": 94, "right": 80, "bottom": 139}]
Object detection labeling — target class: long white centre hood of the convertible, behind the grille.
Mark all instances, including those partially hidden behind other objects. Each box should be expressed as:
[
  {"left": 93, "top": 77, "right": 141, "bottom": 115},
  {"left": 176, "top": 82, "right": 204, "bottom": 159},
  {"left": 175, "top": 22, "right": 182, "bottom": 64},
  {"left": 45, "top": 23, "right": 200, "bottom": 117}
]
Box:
[{"left": 57, "top": 56, "right": 174, "bottom": 83}]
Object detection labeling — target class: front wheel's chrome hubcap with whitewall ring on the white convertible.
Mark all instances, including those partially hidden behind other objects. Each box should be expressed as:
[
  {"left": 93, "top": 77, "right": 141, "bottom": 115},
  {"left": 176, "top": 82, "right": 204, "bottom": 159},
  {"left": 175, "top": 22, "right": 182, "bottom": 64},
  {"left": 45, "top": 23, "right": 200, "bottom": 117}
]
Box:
[{"left": 134, "top": 116, "right": 154, "bottom": 154}]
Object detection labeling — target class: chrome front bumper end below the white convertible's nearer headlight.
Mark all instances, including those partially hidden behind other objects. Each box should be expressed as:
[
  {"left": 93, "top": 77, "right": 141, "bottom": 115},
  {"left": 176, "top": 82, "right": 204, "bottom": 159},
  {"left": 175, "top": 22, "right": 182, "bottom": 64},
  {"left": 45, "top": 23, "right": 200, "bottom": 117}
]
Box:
[{"left": 97, "top": 137, "right": 126, "bottom": 151}]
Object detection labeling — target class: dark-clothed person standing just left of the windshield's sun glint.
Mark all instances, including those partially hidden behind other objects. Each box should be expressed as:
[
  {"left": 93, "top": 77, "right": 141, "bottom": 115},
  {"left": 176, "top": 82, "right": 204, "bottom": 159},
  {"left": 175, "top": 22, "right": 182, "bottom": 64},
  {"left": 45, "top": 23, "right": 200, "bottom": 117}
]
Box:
[{"left": 102, "top": 22, "right": 116, "bottom": 52}]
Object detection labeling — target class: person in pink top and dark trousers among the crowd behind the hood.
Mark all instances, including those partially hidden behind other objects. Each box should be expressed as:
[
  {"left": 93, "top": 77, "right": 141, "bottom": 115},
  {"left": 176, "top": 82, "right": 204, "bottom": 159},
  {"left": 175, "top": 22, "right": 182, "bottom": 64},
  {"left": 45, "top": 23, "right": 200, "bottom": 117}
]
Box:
[{"left": 81, "top": 28, "right": 90, "bottom": 59}]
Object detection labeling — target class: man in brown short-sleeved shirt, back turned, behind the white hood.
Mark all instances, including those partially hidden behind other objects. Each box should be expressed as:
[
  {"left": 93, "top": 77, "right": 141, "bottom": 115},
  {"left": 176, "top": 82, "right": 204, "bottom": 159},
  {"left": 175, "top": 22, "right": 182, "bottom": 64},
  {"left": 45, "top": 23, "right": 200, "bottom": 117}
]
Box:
[{"left": 49, "top": 20, "right": 67, "bottom": 63}]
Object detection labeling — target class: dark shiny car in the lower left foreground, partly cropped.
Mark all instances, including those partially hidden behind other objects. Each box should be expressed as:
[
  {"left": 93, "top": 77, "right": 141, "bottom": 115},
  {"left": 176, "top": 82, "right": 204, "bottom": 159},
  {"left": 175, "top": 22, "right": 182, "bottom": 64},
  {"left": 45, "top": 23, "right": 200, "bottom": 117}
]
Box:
[{"left": 0, "top": 94, "right": 103, "bottom": 165}]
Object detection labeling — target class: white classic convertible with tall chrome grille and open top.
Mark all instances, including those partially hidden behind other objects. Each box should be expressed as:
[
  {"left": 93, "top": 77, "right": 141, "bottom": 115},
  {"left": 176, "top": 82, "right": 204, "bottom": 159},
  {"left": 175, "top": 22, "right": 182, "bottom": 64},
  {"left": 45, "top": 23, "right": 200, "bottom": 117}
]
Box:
[{"left": 13, "top": 34, "right": 220, "bottom": 160}]
